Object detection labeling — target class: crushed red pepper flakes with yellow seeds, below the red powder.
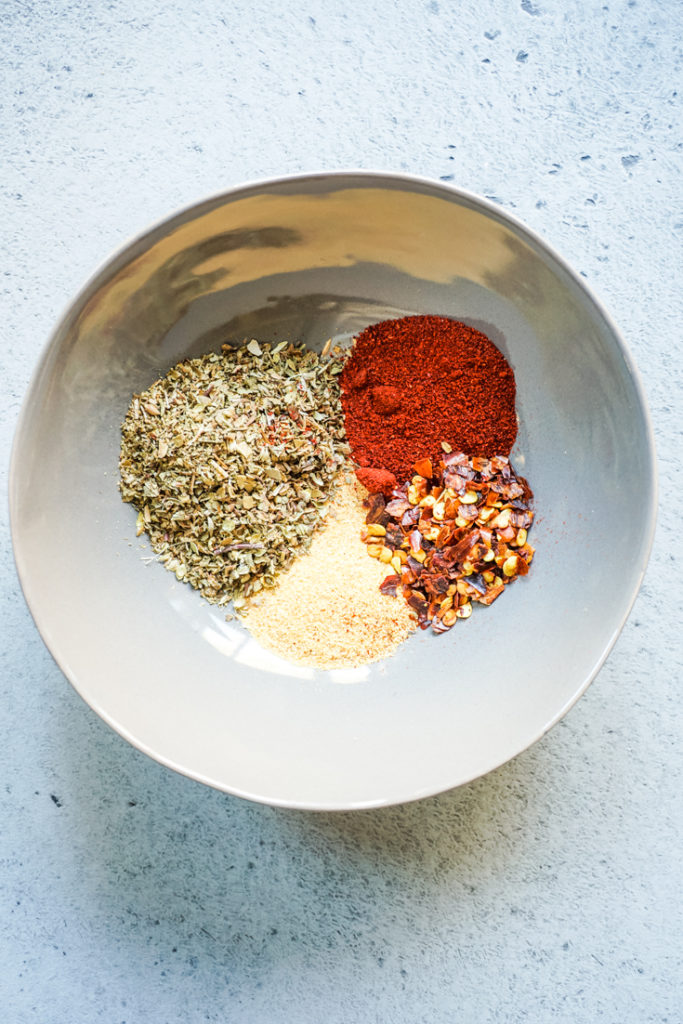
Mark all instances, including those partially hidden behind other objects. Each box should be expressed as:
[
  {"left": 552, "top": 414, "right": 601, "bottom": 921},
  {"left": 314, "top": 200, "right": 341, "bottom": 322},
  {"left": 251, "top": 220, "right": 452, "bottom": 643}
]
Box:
[{"left": 361, "top": 452, "right": 533, "bottom": 633}]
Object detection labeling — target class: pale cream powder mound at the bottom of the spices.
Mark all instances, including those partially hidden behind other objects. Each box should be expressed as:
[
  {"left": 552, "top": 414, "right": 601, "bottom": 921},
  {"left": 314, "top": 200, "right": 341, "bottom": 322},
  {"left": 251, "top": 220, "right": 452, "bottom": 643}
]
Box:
[{"left": 243, "top": 478, "right": 415, "bottom": 669}]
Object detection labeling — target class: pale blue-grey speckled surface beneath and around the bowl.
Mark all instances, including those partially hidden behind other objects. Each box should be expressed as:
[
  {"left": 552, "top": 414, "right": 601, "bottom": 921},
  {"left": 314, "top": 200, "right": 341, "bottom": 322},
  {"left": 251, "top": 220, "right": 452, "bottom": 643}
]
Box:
[{"left": 0, "top": 0, "right": 683, "bottom": 1024}]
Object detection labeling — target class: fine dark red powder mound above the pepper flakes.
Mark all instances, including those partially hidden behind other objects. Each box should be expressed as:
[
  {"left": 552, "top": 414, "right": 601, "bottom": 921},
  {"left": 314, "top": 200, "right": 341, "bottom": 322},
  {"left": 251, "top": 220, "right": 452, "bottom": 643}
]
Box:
[{"left": 340, "top": 316, "right": 517, "bottom": 480}]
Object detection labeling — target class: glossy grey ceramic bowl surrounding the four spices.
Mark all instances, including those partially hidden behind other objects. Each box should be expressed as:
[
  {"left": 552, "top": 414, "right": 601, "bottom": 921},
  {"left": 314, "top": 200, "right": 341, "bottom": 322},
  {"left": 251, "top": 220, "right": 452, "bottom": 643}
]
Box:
[{"left": 10, "top": 173, "right": 656, "bottom": 809}]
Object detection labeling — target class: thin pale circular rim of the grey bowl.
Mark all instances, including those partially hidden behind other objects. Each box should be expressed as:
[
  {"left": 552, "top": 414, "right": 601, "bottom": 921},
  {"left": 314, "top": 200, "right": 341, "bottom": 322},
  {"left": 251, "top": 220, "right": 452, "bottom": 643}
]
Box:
[{"left": 8, "top": 168, "right": 658, "bottom": 812}]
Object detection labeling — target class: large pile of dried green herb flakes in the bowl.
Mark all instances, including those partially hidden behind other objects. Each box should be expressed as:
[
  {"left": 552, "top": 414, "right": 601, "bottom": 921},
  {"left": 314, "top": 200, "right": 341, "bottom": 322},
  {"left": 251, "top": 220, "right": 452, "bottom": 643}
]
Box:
[{"left": 120, "top": 341, "right": 349, "bottom": 606}]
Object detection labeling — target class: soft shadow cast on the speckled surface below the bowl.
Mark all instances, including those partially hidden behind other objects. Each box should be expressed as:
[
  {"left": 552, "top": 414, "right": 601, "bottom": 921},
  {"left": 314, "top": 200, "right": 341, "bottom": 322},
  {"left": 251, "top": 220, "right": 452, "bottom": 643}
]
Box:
[{"left": 53, "top": 694, "right": 559, "bottom": 975}]
